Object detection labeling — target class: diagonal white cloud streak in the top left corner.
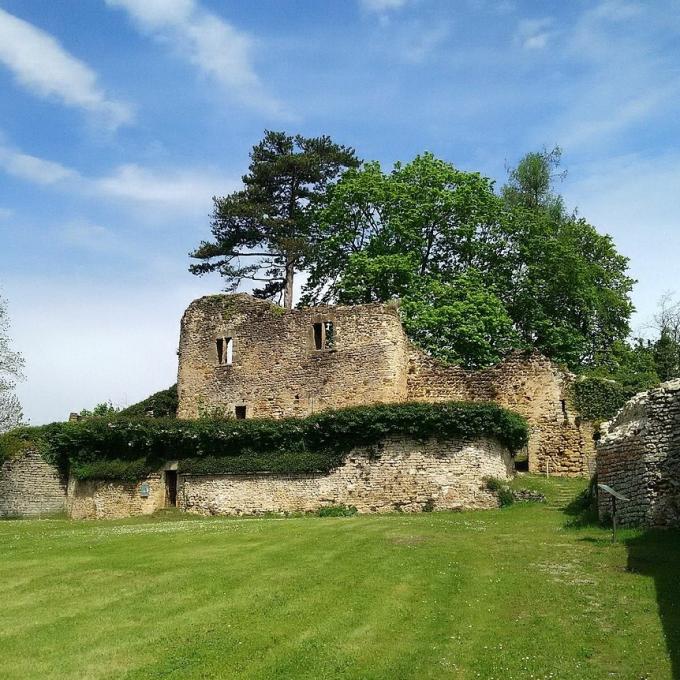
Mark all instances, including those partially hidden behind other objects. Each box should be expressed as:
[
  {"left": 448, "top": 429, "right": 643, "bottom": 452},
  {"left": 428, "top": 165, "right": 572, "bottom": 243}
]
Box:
[{"left": 0, "top": 8, "right": 132, "bottom": 129}]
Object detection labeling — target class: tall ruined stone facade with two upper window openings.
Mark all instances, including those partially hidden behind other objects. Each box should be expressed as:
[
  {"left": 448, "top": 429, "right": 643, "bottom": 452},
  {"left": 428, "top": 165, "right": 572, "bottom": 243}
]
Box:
[{"left": 178, "top": 295, "right": 406, "bottom": 418}]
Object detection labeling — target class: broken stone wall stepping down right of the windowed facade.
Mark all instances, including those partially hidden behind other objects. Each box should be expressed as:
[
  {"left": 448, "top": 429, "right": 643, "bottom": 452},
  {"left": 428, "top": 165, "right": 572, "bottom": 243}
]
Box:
[{"left": 408, "top": 348, "right": 595, "bottom": 476}]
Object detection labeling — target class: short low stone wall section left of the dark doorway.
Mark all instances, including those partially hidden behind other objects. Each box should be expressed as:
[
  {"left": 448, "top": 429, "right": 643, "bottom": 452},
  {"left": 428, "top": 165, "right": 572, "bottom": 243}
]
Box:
[{"left": 66, "top": 472, "right": 166, "bottom": 519}]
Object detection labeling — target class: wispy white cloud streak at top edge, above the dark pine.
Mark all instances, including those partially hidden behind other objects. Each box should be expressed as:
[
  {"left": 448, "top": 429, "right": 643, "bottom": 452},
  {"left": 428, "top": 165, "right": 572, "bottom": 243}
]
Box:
[{"left": 106, "top": 0, "right": 284, "bottom": 115}]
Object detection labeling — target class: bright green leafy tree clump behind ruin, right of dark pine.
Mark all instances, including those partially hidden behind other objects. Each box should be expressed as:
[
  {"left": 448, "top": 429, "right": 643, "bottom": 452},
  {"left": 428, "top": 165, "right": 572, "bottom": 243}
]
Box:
[{"left": 303, "top": 152, "right": 633, "bottom": 369}]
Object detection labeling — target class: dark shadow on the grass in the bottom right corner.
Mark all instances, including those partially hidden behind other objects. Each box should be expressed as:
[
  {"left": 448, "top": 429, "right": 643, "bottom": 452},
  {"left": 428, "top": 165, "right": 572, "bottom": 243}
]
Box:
[{"left": 625, "top": 529, "right": 680, "bottom": 680}]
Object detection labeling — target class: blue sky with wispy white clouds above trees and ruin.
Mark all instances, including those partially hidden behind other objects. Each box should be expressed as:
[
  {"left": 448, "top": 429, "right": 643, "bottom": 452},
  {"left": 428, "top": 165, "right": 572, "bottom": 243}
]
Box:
[{"left": 0, "top": 0, "right": 680, "bottom": 423}]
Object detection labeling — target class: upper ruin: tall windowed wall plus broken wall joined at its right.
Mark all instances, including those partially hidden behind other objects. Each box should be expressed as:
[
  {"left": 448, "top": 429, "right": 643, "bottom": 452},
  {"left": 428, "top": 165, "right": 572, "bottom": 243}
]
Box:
[{"left": 178, "top": 294, "right": 594, "bottom": 475}]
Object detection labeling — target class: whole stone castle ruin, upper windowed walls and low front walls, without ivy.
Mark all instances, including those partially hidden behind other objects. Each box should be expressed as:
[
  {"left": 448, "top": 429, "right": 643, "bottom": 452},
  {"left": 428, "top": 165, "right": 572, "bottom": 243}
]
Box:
[{"left": 0, "top": 294, "right": 594, "bottom": 518}]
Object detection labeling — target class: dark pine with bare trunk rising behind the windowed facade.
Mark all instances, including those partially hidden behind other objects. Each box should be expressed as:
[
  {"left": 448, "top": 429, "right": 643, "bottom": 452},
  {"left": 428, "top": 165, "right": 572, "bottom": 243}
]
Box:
[{"left": 189, "top": 130, "right": 359, "bottom": 309}]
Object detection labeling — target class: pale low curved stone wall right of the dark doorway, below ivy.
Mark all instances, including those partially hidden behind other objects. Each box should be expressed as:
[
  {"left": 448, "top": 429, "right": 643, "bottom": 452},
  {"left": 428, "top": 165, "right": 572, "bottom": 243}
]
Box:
[{"left": 178, "top": 438, "right": 512, "bottom": 515}]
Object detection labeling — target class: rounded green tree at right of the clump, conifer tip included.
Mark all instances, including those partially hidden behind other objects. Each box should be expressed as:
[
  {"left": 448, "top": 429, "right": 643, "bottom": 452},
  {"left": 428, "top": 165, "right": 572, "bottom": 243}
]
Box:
[{"left": 501, "top": 147, "right": 635, "bottom": 370}]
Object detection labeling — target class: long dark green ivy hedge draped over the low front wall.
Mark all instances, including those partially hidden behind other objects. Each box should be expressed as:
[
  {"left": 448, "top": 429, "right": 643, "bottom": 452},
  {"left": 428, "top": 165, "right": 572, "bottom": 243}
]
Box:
[{"left": 0, "top": 402, "right": 528, "bottom": 480}]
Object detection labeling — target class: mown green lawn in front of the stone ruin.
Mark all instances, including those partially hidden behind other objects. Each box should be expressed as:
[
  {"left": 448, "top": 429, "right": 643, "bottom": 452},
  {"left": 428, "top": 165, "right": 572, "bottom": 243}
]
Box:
[{"left": 0, "top": 479, "right": 680, "bottom": 680}]
